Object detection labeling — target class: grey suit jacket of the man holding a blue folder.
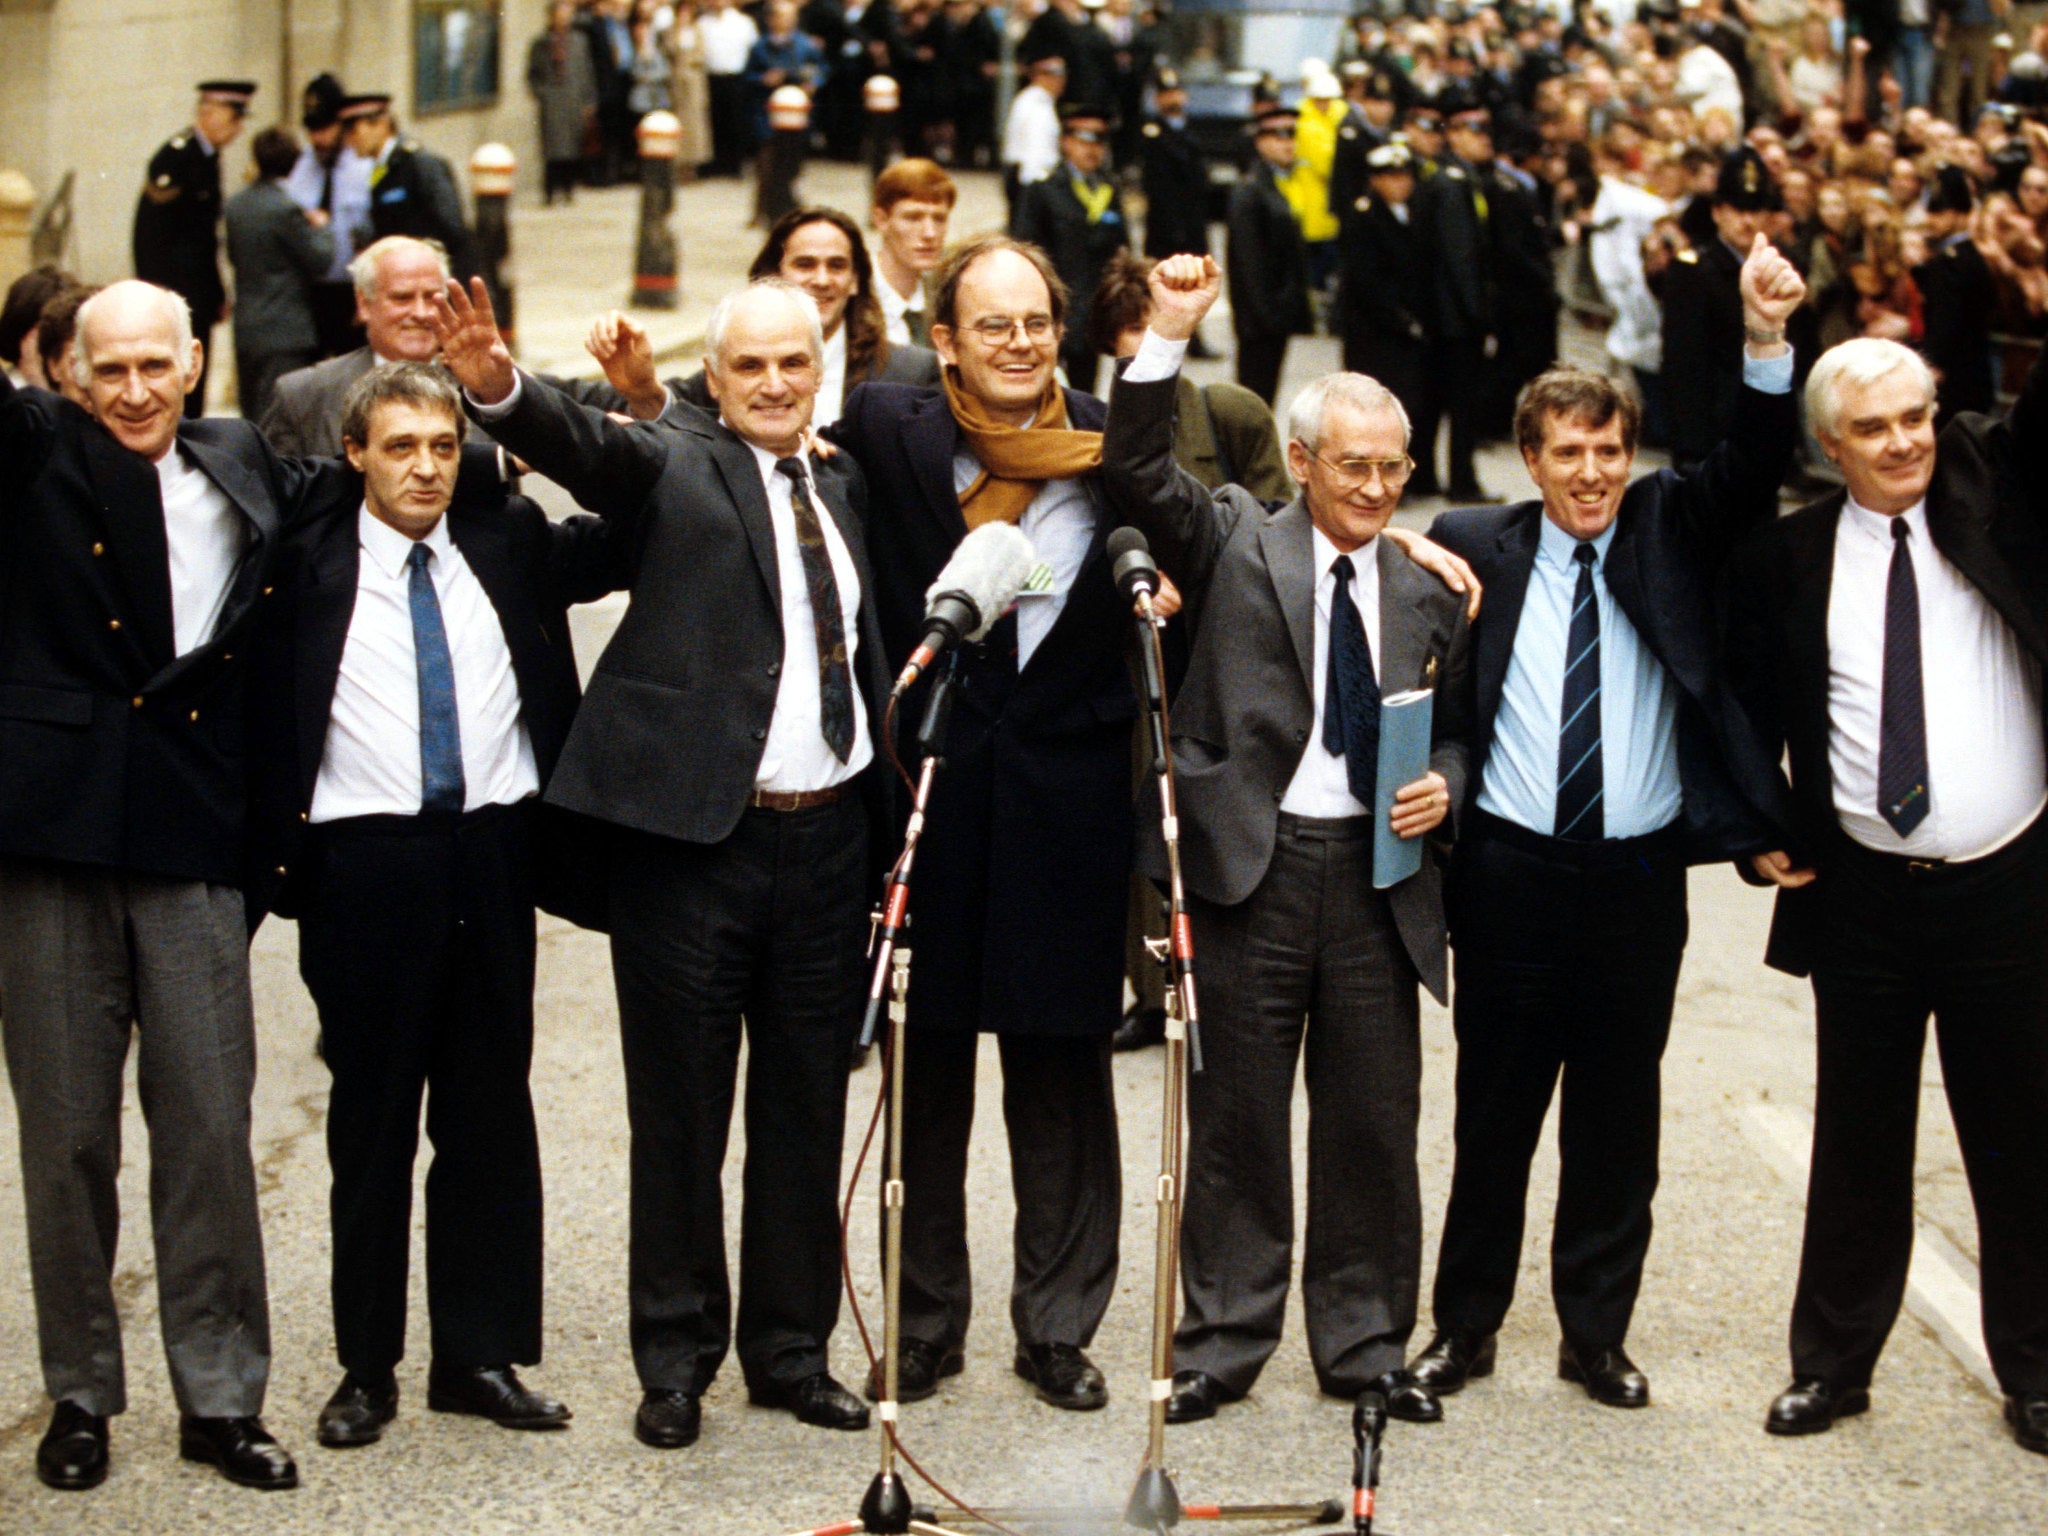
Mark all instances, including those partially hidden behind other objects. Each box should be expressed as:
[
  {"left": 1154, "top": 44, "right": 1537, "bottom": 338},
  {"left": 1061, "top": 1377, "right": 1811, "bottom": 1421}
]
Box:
[{"left": 1102, "top": 368, "right": 1470, "bottom": 1001}]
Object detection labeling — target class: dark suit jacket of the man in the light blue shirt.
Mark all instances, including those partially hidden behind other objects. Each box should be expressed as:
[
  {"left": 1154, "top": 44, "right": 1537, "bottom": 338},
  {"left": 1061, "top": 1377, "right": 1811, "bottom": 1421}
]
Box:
[{"left": 1430, "top": 374, "right": 1798, "bottom": 864}]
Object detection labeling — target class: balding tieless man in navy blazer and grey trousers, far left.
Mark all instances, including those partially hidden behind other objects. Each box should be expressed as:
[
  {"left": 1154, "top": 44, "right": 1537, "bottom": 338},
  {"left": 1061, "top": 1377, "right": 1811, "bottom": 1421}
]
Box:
[{"left": 0, "top": 283, "right": 380, "bottom": 1489}]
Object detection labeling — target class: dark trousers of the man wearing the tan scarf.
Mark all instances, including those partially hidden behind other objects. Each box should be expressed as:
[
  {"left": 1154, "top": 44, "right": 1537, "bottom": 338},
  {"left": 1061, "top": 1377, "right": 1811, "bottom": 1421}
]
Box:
[{"left": 903, "top": 1030, "right": 1122, "bottom": 1350}]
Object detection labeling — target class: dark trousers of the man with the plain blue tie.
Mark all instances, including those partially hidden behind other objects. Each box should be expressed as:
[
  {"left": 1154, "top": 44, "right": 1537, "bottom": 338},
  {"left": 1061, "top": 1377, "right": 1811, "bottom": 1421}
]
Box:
[{"left": 299, "top": 805, "right": 543, "bottom": 1380}]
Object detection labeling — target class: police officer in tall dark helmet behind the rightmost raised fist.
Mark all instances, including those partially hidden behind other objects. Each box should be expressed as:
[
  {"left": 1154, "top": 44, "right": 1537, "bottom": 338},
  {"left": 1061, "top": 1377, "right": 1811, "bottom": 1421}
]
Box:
[{"left": 1659, "top": 145, "right": 1784, "bottom": 473}]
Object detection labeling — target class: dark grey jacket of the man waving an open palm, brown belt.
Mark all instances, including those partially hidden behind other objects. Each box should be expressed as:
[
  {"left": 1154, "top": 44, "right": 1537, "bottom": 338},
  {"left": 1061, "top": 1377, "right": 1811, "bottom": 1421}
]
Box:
[{"left": 471, "top": 377, "right": 888, "bottom": 844}]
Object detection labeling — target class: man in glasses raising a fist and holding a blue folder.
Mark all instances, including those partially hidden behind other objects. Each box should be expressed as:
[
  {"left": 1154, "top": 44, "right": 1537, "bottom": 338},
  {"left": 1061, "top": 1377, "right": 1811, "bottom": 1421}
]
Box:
[{"left": 1104, "top": 256, "right": 1470, "bottom": 1423}]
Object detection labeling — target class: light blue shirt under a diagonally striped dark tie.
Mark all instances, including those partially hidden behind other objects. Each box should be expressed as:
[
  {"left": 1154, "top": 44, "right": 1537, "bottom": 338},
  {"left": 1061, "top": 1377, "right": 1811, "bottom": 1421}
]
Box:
[{"left": 1479, "top": 354, "right": 1792, "bottom": 838}]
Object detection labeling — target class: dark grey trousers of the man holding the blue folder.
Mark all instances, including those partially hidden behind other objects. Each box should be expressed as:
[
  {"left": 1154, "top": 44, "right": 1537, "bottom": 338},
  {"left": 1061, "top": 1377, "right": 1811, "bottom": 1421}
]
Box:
[{"left": 1174, "top": 813, "right": 1421, "bottom": 1397}]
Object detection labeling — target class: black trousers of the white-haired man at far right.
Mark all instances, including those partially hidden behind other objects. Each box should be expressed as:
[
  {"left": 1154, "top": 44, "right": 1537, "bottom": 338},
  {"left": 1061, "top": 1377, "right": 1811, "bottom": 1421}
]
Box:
[{"left": 1792, "top": 825, "right": 2048, "bottom": 1393}]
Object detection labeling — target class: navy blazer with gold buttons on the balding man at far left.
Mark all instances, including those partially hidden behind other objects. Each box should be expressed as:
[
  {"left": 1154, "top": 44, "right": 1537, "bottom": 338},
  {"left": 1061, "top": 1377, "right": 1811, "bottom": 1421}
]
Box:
[{"left": 0, "top": 364, "right": 348, "bottom": 885}]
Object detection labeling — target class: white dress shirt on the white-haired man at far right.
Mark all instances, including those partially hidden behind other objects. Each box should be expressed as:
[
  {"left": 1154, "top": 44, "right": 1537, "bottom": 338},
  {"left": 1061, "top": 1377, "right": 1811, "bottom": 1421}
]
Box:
[{"left": 1827, "top": 500, "right": 2048, "bottom": 860}]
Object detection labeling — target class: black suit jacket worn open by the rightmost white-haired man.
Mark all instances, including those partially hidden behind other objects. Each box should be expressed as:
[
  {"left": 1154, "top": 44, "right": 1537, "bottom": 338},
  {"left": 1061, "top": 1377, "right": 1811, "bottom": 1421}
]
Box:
[{"left": 1729, "top": 352, "right": 2048, "bottom": 975}]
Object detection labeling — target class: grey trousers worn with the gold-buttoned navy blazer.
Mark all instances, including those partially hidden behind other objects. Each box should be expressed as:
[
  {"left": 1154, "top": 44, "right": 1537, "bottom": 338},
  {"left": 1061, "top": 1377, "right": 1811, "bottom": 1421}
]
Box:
[{"left": 0, "top": 858, "right": 270, "bottom": 1417}]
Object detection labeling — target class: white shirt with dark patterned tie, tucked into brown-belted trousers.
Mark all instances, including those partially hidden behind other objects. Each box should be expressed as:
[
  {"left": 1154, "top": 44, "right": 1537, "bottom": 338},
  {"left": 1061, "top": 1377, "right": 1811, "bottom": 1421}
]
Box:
[{"left": 748, "top": 442, "right": 874, "bottom": 793}]
